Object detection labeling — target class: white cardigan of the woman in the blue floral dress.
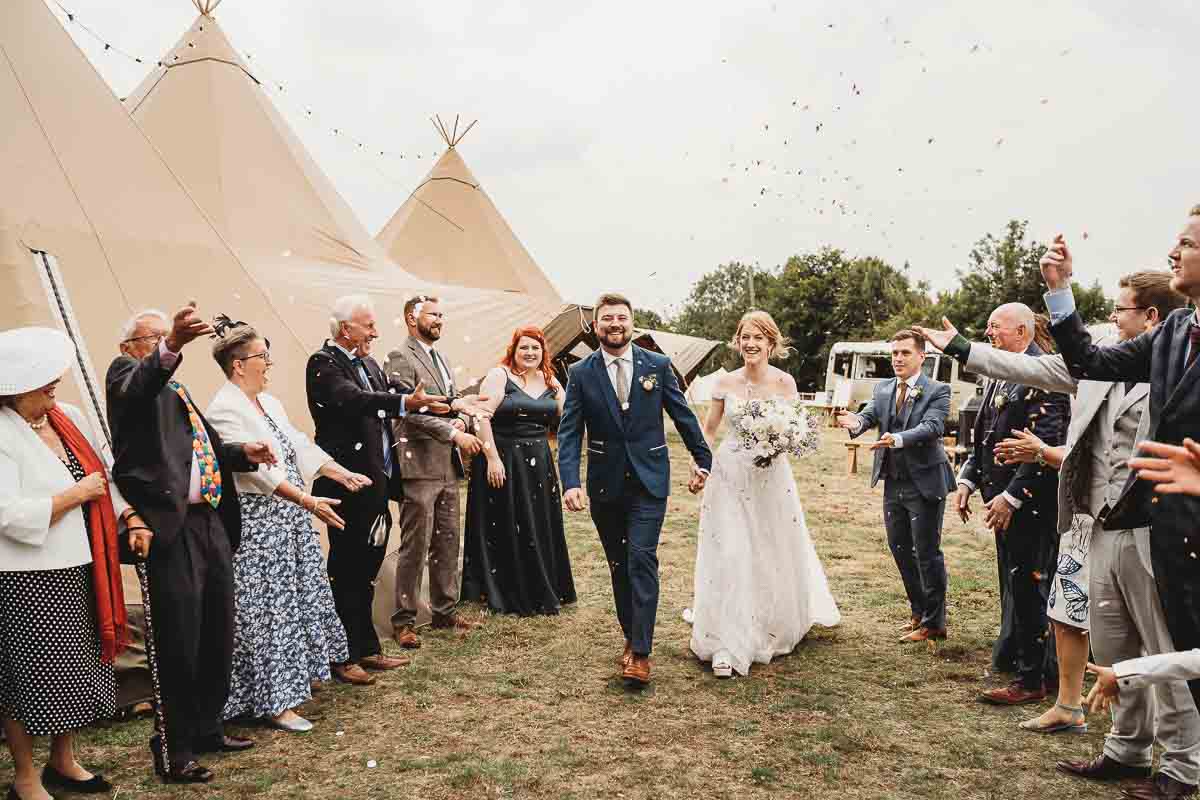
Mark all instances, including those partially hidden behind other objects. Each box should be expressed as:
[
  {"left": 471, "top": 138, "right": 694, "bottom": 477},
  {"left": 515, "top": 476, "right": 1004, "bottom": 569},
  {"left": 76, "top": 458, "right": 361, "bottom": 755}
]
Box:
[{"left": 204, "top": 380, "right": 334, "bottom": 494}]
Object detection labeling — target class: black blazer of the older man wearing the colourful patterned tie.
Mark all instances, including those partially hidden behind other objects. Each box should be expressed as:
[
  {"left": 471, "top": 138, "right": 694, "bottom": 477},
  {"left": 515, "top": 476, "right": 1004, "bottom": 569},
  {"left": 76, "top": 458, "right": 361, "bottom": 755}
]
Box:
[{"left": 104, "top": 349, "right": 258, "bottom": 558}]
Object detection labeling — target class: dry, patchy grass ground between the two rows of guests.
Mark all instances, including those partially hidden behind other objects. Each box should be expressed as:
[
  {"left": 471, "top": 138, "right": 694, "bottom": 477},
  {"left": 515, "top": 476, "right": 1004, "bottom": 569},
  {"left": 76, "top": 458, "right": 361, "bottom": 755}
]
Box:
[{"left": 0, "top": 432, "right": 1120, "bottom": 800}]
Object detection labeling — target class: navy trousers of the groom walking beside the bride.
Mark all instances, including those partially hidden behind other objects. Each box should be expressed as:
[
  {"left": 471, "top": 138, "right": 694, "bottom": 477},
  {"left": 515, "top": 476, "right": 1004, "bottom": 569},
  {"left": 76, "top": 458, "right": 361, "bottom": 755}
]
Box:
[{"left": 592, "top": 477, "right": 667, "bottom": 656}]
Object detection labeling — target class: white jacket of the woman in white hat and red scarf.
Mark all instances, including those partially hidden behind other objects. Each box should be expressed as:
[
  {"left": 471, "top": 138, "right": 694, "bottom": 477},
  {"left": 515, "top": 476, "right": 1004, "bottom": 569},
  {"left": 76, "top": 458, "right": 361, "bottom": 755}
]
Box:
[{"left": 0, "top": 403, "right": 130, "bottom": 572}]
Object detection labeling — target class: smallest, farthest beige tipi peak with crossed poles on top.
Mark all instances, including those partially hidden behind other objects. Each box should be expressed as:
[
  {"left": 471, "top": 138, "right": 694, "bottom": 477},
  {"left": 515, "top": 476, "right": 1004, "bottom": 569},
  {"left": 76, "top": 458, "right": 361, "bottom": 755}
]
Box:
[{"left": 376, "top": 119, "right": 562, "bottom": 302}]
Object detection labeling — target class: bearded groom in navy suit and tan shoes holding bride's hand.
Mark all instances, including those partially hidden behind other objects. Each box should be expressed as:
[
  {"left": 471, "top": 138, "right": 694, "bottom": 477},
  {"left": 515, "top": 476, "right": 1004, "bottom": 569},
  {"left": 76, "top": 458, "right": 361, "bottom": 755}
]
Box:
[{"left": 558, "top": 293, "right": 713, "bottom": 687}]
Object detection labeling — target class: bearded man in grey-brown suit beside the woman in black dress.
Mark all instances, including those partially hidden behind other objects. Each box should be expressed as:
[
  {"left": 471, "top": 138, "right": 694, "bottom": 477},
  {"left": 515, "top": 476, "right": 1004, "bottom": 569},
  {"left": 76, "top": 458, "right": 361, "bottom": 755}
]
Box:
[{"left": 388, "top": 295, "right": 482, "bottom": 649}]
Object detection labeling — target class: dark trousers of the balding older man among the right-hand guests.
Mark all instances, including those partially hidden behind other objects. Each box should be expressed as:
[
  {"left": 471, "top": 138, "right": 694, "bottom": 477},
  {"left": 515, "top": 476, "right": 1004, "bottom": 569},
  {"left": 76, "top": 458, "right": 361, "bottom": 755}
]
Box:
[{"left": 996, "top": 509, "right": 1058, "bottom": 688}]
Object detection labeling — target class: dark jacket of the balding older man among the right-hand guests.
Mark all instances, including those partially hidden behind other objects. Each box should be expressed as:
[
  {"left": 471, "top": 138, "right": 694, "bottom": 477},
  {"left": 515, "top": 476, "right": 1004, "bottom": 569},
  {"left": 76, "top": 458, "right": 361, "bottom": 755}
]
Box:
[{"left": 959, "top": 344, "right": 1070, "bottom": 528}]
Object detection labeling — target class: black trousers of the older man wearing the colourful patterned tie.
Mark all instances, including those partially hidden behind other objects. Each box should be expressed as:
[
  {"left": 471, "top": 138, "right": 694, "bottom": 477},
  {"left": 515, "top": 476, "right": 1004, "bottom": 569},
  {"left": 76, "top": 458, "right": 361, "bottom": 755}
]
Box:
[{"left": 148, "top": 505, "right": 234, "bottom": 766}]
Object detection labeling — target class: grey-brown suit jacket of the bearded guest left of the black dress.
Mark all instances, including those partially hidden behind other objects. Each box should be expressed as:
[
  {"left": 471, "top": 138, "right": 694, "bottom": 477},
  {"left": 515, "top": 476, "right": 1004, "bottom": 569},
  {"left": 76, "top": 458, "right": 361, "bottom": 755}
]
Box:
[{"left": 385, "top": 337, "right": 469, "bottom": 481}]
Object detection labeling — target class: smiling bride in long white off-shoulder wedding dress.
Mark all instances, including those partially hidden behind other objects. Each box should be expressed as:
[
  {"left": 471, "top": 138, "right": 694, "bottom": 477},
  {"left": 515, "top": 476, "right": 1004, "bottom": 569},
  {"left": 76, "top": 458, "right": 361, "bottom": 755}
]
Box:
[{"left": 691, "top": 311, "right": 841, "bottom": 678}]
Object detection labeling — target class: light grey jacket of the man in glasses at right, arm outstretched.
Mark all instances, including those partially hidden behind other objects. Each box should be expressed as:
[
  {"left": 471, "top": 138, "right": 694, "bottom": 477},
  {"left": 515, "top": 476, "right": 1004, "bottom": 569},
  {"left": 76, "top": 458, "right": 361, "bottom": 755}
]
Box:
[{"left": 966, "top": 342, "right": 1150, "bottom": 533}]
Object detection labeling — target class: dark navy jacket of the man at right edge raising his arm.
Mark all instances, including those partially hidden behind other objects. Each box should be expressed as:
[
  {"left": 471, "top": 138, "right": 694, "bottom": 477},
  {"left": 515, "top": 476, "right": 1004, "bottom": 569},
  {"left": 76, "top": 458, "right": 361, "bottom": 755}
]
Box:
[{"left": 1050, "top": 308, "right": 1200, "bottom": 534}]
